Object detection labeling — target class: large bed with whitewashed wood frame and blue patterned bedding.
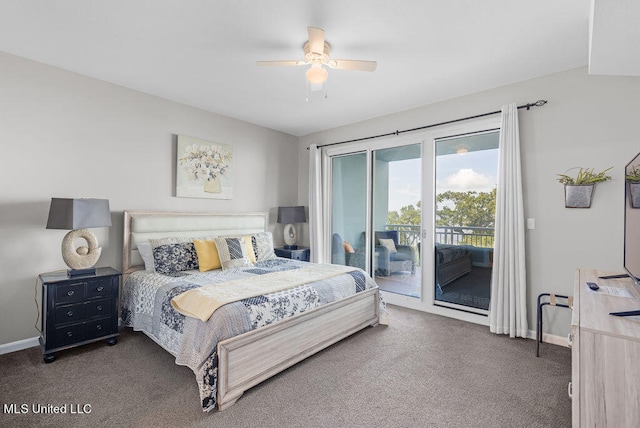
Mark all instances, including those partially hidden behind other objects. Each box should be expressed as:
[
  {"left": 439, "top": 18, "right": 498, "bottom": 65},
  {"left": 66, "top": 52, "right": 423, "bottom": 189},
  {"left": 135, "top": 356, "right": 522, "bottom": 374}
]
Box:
[{"left": 121, "top": 211, "right": 381, "bottom": 411}]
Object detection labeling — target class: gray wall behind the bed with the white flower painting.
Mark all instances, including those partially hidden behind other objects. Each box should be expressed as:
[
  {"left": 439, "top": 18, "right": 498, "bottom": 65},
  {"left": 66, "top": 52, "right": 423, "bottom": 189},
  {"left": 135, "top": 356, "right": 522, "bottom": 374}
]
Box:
[{"left": 0, "top": 53, "right": 306, "bottom": 345}]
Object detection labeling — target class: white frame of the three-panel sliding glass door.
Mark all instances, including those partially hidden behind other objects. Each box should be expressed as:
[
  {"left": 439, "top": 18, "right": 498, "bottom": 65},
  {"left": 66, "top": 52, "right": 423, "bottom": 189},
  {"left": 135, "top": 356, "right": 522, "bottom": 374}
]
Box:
[{"left": 322, "top": 114, "right": 501, "bottom": 325}]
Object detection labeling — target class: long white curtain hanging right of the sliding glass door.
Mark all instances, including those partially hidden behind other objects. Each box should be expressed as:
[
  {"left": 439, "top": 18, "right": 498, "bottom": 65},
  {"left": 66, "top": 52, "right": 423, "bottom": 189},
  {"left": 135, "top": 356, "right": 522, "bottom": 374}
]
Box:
[{"left": 489, "top": 104, "right": 528, "bottom": 337}]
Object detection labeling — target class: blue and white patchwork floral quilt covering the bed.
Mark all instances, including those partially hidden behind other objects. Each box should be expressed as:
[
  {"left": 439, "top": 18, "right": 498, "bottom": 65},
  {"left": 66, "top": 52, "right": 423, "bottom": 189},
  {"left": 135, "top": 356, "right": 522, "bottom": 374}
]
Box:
[{"left": 122, "top": 258, "right": 377, "bottom": 411}]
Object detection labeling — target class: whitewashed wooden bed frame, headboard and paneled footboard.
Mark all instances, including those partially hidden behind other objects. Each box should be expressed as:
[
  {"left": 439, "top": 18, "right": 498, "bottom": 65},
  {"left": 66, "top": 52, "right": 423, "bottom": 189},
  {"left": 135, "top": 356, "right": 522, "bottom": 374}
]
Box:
[{"left": 122, "top": 211, "right": 379, "bottom": 410}]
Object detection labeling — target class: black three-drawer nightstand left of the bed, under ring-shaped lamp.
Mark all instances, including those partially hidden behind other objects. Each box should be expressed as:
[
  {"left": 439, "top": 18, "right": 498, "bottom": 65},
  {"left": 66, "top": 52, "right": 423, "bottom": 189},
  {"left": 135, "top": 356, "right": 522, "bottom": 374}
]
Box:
[{"left": 38, "top": 267, "right": 121, "bottom": 363}]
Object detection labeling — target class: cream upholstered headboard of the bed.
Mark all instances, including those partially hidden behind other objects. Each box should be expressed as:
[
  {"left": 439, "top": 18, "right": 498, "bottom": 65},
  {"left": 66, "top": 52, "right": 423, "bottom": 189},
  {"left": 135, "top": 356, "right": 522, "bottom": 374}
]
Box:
[{"left": 122, "top": 211, "right": 268, "bottom": 278}]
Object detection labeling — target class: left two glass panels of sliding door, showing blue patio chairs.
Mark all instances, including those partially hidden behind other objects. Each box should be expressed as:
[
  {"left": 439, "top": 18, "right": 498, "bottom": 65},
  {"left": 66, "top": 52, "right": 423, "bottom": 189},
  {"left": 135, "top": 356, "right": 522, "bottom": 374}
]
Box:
[{"left": 330, "top": 144, "right": 422, "bottom": 298}]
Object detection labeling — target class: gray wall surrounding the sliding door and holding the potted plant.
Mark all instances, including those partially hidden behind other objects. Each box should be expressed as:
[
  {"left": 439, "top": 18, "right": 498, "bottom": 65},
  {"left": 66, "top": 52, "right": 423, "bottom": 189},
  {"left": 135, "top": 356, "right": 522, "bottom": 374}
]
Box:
[{"left": 298, "top": 68, "right": 640, "bottom": 336}]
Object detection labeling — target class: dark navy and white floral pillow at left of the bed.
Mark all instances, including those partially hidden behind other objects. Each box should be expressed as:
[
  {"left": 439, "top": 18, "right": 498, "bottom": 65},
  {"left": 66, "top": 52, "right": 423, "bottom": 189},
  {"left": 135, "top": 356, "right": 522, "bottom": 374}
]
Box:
[{"left": 149, "top": 238, "right": 198, "bottom": 275}]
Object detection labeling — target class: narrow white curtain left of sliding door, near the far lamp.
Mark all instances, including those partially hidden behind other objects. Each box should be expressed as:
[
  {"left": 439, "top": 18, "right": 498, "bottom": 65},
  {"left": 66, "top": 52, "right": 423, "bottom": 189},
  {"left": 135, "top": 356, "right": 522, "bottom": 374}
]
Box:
[{"left": 309, "top": 144, "right": 325, "bottom": 263}]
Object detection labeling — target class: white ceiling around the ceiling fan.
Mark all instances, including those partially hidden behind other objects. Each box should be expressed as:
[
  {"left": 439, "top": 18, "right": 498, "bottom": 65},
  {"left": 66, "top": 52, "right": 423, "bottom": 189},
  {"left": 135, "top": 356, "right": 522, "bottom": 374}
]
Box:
[{"left": 0, "top": 0, "right": 636, "bottom": 136}]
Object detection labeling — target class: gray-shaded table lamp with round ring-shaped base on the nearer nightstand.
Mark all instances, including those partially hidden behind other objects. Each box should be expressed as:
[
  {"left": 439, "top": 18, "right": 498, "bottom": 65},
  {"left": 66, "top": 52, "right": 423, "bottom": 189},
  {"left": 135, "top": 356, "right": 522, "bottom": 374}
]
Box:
[{"left": 47, "top": 198, "right": 111, "bottom": 276}]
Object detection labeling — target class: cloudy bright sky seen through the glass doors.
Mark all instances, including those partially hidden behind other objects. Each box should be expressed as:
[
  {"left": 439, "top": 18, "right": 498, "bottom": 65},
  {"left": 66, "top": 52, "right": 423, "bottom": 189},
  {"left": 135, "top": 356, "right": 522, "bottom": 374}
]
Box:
[{"left": 389, "top": 149, "right": 498, "bottom": 212}]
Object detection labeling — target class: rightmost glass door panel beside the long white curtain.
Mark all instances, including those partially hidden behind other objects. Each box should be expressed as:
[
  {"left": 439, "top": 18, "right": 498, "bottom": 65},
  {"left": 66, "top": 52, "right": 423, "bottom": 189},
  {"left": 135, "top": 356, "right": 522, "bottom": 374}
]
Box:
[{"left": 433, "top": 131, "right": 499, "bottom": 313}]
